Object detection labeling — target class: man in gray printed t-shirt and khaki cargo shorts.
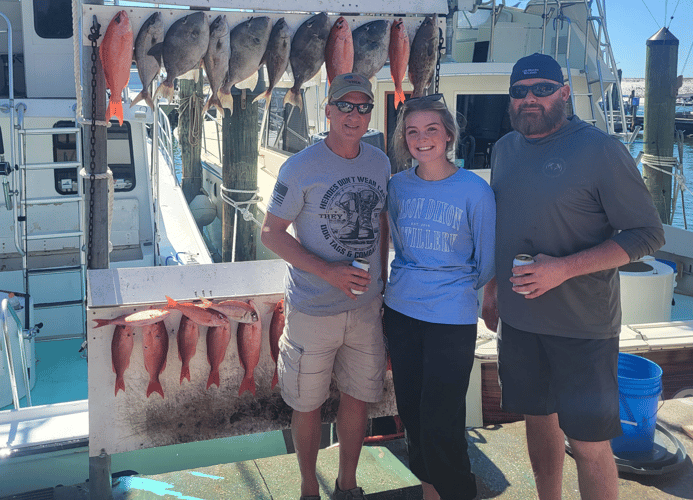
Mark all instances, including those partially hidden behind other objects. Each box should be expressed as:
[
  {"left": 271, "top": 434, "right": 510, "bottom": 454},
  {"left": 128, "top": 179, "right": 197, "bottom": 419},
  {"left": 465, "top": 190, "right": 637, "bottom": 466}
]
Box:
[{"left": 262, "top": 73, "right": 390, "bottom": 500}]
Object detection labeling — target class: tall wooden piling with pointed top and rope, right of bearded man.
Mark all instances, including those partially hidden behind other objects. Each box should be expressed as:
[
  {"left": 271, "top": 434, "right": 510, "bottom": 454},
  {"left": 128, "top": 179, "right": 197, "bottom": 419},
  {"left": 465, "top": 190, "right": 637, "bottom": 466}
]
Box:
[{"left": 643, "top": 28, "right": 679, "bottom": 224}]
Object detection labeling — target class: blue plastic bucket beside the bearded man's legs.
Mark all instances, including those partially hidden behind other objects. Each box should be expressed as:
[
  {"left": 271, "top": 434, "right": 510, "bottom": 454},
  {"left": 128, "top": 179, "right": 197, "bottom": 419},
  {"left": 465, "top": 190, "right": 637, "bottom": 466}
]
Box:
[{"left": 611, "top": 352, "right": 662, "bottom": 454}]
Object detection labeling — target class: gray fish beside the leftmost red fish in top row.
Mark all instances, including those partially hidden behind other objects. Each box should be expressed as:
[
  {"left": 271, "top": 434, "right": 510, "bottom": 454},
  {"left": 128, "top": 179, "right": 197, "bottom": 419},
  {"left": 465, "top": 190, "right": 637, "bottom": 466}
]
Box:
[{"left": 130, "top": 12, "right": 164, "bottom": 109}]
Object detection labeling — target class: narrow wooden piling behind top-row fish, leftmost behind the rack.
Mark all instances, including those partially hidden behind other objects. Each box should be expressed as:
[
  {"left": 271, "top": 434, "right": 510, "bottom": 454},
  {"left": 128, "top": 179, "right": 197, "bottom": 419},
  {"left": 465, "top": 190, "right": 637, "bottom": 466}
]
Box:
[{"left": 178, "top": 69, "right": 204, "bottom": 203}]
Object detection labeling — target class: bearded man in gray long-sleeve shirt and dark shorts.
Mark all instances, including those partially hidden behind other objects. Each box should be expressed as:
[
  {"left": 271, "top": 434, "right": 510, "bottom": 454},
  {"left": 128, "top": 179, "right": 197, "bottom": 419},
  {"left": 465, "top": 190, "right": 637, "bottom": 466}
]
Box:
[{"left": 482, "top": 54, "right": 664, "bottom": 500}]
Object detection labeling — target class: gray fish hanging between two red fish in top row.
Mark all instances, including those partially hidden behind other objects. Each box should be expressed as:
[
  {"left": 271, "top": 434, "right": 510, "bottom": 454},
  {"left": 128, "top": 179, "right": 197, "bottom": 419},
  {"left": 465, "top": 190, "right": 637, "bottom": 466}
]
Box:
[{"left": 352, "top": 19, "right": 390, "bottom": 80}]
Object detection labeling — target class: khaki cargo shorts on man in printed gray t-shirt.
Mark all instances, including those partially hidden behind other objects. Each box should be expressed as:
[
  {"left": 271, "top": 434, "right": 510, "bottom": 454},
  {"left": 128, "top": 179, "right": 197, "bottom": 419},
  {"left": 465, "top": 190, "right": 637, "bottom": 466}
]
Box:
[{"left": 277, "top": 297, "right": 387, "bottom": 412}]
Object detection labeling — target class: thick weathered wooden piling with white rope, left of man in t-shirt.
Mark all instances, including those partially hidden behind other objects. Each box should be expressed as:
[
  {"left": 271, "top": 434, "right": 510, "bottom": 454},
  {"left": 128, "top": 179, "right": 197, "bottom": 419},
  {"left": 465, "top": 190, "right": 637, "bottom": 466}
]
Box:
[{"left": 221, "top": 89, "right": 258, "bottom": 262}]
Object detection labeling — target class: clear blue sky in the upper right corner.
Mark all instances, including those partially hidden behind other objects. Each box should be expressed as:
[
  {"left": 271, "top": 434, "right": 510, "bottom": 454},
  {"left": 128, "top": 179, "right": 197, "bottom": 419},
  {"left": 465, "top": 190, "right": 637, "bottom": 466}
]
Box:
[{"left": 520, "top": 0, "right": 693, "bottom": 78}]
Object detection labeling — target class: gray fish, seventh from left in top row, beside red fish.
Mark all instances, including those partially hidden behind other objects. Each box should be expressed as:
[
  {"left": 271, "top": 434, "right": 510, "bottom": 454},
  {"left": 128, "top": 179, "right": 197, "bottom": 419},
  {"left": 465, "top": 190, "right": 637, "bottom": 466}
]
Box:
[{"left": 284, "top": 12, "right": 332, "bottom": 109}]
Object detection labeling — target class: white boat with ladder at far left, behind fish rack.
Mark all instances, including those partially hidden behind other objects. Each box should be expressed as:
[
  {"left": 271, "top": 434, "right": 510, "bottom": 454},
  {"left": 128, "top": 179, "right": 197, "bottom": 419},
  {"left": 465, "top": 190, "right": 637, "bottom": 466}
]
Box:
[{"left": 0, "top": 0, "right": 212, "bottom": 496}]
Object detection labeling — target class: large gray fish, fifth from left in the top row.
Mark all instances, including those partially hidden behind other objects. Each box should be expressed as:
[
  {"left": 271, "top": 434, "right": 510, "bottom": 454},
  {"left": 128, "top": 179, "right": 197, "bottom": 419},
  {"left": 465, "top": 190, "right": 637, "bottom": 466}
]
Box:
[{"left": 218, "top": 16, "right": 272, "bottom": 113}]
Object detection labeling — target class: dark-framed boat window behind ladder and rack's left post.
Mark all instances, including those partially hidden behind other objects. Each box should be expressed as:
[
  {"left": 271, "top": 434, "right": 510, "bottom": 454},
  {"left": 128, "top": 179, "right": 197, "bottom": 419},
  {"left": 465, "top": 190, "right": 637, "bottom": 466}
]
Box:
[{"left": 53, "top": 121, "right": 136, "bottom": 195}]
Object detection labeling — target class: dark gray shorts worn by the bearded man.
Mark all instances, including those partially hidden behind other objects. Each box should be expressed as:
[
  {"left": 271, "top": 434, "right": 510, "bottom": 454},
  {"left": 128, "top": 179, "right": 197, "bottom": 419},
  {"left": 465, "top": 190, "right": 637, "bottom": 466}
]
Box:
[{"left": 498, "top": 323, "right": 621, "bottom": 442}]
